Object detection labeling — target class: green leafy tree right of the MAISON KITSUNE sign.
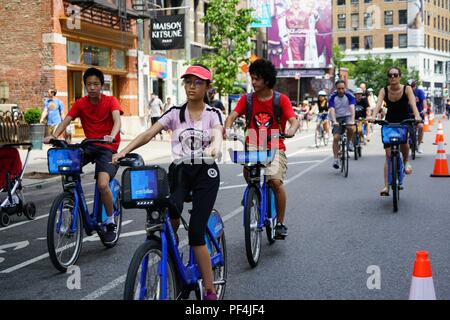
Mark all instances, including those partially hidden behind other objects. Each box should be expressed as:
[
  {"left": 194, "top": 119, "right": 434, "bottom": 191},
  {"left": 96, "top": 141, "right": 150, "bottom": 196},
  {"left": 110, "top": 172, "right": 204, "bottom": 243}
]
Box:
[{"left": 190, "top": 0, "right": 256, "bottom": 95}]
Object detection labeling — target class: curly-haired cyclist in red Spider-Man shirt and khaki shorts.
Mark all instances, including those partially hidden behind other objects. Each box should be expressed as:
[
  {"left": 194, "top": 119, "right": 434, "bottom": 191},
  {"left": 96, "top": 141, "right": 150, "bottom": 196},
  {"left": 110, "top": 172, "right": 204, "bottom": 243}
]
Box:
[{"left": 225, "top": 59, "right": 299, "bottom": 238}]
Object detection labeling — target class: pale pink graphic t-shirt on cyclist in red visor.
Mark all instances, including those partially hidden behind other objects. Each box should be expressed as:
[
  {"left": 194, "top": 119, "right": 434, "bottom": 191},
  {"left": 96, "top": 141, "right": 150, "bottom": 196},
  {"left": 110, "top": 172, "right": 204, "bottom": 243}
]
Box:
[{"left": 158, "top": 104, "right": 223, "bottom": 159}]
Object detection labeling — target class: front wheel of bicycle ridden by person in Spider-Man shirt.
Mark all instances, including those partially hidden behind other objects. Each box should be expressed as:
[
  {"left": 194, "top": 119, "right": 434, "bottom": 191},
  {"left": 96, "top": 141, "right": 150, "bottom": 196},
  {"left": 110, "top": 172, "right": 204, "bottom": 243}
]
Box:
[{"left": 244, "top": 187, "right": 261, "bottom": 268}]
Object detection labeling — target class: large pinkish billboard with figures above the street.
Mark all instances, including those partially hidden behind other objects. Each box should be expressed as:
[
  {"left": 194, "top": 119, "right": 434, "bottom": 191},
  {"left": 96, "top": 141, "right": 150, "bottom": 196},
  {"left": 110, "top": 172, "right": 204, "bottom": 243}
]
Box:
[{"left": 267, "top": 0, "right": 332, "bottom": 69}]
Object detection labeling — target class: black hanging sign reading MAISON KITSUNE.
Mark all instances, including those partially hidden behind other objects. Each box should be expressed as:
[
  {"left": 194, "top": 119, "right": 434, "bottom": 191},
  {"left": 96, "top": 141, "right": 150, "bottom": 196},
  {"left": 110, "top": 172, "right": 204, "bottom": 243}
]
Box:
[{"left": 150, "top": 14, "right": 185, "bottom": 50}]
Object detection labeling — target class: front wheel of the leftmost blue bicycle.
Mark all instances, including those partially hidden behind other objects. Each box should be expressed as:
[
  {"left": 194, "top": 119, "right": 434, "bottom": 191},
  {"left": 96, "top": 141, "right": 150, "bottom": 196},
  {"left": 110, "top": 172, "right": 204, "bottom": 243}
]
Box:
[{"left": 47, "top": 192, "right": 83, "bottom": 272}]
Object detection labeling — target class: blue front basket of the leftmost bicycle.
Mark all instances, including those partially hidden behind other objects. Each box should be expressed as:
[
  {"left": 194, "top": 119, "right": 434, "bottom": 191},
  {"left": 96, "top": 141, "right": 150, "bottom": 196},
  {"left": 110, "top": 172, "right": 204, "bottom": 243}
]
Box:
[{"left": 47, "top": 148, "right": 83, "bottom": 174}]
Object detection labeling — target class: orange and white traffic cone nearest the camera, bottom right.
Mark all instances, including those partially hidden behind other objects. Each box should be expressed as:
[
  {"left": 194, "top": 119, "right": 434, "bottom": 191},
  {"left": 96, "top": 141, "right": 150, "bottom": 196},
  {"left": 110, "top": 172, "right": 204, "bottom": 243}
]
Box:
[{"left": 409, "top": 251, "right": 436, "bottom": 300}]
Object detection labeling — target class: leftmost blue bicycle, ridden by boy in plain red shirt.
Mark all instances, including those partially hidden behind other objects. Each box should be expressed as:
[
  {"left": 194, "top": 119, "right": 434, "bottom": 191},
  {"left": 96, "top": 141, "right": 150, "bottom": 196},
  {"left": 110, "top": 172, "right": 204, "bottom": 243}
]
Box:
[{"left": 47, "top": 139, "right": 122, "bottom": 272}]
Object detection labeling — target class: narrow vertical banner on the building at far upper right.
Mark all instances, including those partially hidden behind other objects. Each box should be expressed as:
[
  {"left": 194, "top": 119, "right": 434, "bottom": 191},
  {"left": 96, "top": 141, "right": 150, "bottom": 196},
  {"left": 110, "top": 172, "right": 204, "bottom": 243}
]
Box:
[{"left": 408, "top": 0, "right": 425, "bottom": 47}]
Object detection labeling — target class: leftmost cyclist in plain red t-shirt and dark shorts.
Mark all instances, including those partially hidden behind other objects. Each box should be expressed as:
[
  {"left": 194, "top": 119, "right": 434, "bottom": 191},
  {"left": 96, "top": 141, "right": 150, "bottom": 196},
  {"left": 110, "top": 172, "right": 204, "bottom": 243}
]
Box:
[{"left": 44, "top": 68, "right": 123, "bottom": 243}]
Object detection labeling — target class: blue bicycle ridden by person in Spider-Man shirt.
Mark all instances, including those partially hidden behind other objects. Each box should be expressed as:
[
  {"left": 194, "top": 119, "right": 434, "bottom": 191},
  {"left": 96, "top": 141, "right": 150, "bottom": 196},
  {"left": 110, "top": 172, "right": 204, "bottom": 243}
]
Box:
[{"left": 229, "top": 134, "right": 284, "bottom": 268}]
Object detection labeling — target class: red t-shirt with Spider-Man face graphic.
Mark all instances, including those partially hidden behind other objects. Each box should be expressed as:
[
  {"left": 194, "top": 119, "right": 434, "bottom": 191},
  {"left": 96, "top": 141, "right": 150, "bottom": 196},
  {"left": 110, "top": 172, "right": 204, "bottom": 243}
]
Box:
[{"left": 234, "top": 94, "right": 296, "bottom": 151}]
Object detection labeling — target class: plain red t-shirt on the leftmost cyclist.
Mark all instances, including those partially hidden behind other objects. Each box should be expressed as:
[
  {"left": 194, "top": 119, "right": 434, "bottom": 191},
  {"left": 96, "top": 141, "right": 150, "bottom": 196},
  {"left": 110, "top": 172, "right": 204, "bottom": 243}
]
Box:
[{"left": 67, "top": 94, "right": 123, "bottom": 153}]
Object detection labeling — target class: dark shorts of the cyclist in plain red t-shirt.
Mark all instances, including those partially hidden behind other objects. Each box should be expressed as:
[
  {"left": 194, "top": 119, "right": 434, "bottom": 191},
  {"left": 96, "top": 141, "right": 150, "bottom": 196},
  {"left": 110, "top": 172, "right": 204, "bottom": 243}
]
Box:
[{"left": 83, "top": 145, "right": 119, "bottom": 181}]
